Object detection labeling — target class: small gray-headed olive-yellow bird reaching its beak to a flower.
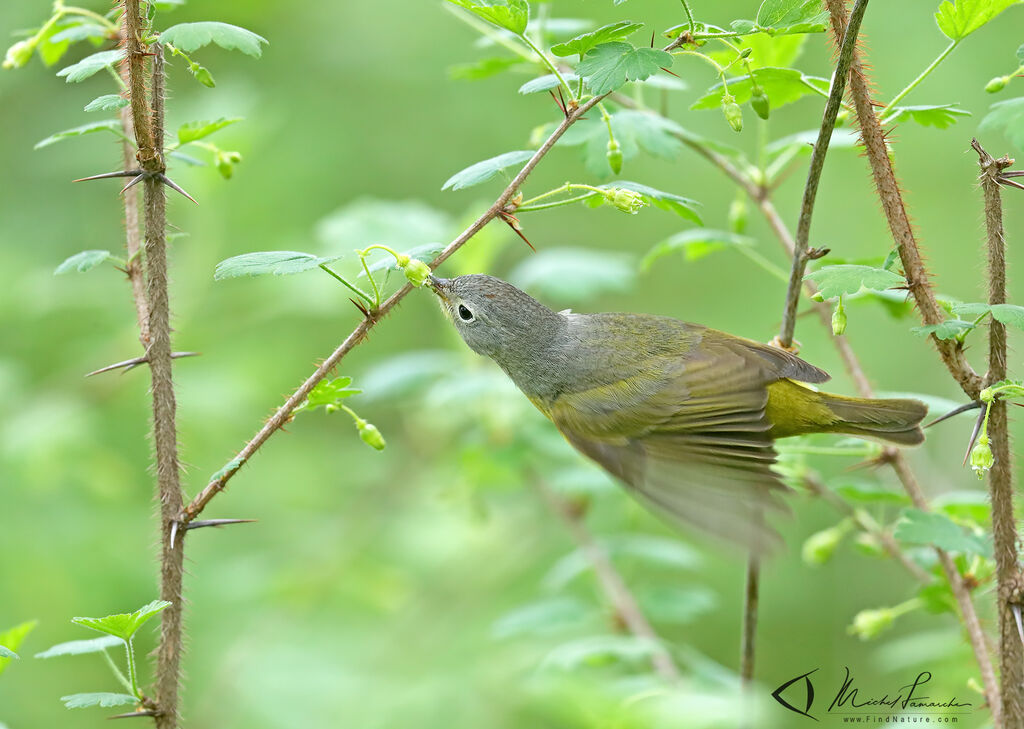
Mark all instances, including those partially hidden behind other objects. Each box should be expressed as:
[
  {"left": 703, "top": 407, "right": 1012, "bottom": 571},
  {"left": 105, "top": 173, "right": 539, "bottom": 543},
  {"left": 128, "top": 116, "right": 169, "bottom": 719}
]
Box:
[{"left": 427, "top": 273, "right": 928, "bottom": 553}]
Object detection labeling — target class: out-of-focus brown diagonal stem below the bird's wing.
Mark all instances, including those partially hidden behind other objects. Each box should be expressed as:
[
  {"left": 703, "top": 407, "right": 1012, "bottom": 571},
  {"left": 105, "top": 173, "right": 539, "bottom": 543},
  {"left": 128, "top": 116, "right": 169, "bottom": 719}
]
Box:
[{"left": 531, "top": 476, "right": 680, "bottom": 682}]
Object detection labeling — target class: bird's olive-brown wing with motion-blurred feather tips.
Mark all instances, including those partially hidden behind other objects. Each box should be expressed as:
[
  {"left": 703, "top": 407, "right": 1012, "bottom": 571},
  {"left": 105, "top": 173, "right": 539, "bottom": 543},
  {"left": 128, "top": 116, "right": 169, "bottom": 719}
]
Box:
[{"left": 549, "top": 330, "right": 827, "bottom": 550}]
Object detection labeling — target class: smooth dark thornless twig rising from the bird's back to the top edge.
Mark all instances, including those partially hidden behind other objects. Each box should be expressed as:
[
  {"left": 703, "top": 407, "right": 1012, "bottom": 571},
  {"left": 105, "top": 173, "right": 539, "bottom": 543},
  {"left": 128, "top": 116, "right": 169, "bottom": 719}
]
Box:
[{"left": 778, "top": 0, "right": 867, "bottom": 349}]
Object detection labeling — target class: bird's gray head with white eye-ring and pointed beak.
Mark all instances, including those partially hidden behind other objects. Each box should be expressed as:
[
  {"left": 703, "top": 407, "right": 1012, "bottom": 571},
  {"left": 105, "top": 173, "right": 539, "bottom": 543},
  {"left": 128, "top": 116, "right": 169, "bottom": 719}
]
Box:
[{"left": 429, "top": 273, "right": 565, "bottom": 364}]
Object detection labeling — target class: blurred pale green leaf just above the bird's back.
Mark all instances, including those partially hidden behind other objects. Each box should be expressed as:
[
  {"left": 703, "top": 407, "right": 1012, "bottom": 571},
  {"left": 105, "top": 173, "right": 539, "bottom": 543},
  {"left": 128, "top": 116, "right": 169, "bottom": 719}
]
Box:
[{"left": 509, "top": 248, "right": 634, "bottom": 303}]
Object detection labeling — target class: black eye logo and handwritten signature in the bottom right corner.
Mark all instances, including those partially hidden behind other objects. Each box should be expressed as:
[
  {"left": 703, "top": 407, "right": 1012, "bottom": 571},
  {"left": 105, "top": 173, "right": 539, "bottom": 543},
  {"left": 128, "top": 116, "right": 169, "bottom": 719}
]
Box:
[{"left": 771, "top": 667, "right": 972, "bottom": 721}]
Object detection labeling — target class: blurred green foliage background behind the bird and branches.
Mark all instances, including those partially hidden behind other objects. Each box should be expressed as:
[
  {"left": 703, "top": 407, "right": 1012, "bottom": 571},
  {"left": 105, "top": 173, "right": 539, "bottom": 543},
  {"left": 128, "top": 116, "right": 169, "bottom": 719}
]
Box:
[{"left": 0, "top": 0, "right": 1024, "bottom": 729}]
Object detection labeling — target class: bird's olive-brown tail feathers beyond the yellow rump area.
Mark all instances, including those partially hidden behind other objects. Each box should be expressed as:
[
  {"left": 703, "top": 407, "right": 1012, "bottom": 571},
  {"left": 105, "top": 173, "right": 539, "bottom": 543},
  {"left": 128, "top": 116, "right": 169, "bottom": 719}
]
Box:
[{"left": 819, "top": 392, "right": 928, "bottom": 445}]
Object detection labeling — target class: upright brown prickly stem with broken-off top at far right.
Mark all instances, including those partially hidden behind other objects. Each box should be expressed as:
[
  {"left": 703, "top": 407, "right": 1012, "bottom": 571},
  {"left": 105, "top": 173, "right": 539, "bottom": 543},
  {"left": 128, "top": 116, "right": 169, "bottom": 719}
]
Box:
[{"left": 971, "top": 139, "right": 1024, "bottom": 727}]
